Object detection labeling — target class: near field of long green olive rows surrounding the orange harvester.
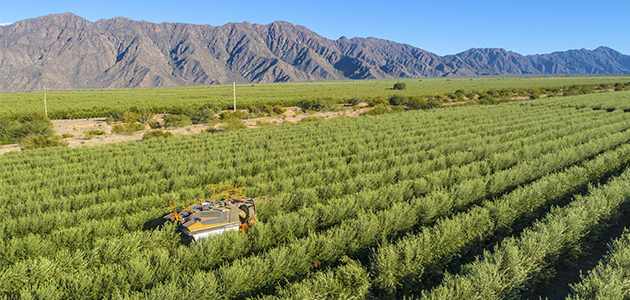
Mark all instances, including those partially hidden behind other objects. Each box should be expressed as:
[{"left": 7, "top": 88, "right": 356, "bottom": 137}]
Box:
[{"left": 0, "top": 90, "right": 630, "bottom": 299}]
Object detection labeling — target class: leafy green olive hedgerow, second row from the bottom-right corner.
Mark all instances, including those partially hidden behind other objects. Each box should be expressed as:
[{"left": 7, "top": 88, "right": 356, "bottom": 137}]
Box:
[{"left": 424, "top": 164, "right": 630, "bottom": 299}]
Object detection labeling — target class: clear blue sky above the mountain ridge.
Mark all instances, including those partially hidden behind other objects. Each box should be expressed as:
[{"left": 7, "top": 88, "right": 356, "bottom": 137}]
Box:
[{"left": 0, "top": 0, "right": 630, "bottom": 55}]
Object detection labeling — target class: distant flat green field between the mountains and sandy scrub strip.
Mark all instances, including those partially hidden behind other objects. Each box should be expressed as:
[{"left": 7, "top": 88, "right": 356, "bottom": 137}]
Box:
[{"left": 0, "top": 76, "right": 630, "bottom": 119}]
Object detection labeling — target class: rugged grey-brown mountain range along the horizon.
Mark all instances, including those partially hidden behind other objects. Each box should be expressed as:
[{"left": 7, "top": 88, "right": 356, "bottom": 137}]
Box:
[{"left": 0, "top": 13, "right": 630, "bottom": 92}]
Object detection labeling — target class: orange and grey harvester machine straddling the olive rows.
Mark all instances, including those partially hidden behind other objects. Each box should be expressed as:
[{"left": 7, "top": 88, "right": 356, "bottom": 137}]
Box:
[{"left": 164, "top": 184, "right": 264, "bottom": 241}]
